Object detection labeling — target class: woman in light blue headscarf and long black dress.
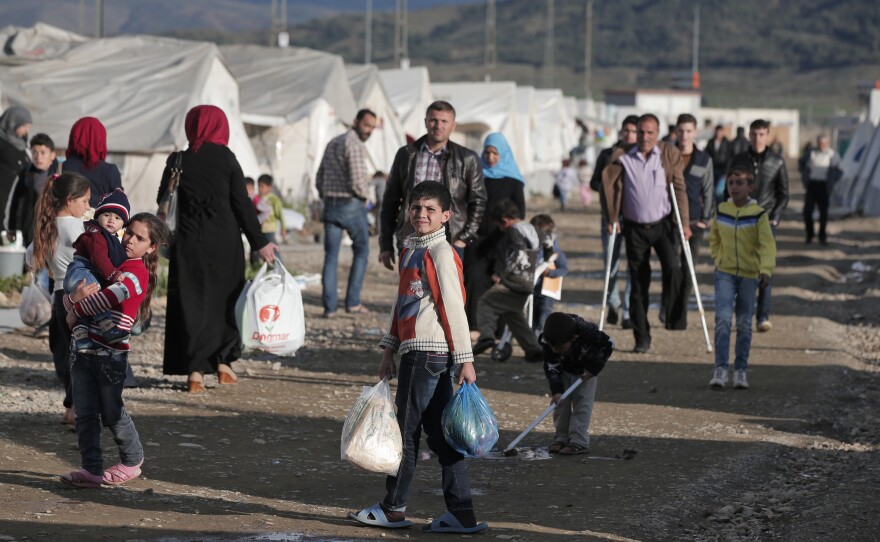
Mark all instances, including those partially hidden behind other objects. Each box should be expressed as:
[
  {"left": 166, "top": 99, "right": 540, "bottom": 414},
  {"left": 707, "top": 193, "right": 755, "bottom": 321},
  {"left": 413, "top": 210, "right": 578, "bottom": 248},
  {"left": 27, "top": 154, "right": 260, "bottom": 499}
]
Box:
[{"left": 464, "top": 132, "right": 526, "bottom": 331}]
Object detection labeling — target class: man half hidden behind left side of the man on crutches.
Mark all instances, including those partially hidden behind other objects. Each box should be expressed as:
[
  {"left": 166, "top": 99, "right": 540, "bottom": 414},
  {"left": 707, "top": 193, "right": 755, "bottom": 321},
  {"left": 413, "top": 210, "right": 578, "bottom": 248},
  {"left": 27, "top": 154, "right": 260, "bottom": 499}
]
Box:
[{"left": 590, "top": 115, "right": 639, "bottom": 329}]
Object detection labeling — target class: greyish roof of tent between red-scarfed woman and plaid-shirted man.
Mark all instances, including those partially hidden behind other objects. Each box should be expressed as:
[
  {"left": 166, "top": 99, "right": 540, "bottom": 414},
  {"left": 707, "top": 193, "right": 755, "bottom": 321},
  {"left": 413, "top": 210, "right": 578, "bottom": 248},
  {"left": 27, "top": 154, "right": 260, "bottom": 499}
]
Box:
[{"left": 220, "top": 45, "right": 357, "bottom": 126}]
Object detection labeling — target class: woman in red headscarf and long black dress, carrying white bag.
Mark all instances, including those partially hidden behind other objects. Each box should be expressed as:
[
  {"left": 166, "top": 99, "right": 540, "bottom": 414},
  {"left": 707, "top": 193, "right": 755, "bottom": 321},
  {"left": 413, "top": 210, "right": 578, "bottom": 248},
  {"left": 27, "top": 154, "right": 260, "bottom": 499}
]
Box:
[{"left": 158, "top": 105, "right": 278, "bottom": 393}]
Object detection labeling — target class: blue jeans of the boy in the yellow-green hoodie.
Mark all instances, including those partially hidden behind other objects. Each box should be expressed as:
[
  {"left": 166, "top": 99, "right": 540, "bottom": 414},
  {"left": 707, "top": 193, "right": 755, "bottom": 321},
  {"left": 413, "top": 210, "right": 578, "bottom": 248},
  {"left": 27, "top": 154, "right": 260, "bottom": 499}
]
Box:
[{"left": 715, "top": 269, "right": 758, "bottom": 370}]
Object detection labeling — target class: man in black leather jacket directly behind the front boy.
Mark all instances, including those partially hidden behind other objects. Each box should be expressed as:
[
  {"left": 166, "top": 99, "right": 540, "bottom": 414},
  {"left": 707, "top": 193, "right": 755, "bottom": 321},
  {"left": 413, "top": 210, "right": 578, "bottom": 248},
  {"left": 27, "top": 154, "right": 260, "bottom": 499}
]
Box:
[{"left": 379, "top": 101, "right": 486, "bottom": 269}]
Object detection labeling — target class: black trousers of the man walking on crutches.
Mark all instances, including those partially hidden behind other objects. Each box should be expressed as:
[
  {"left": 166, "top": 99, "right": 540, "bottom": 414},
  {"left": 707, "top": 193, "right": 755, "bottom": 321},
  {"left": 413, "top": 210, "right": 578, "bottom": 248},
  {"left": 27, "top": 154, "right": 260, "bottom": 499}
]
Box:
[{"left": 623, "top": 215, "right": 687, "bottom": 345}]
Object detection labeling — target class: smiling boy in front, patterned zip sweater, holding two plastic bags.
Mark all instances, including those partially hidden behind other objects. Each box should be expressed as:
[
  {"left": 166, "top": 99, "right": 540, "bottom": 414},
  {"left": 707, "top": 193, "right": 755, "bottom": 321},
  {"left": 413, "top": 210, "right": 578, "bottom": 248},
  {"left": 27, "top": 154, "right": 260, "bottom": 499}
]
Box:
[{"left": 349, "top": 181, "right": 487, "bottom": 533}]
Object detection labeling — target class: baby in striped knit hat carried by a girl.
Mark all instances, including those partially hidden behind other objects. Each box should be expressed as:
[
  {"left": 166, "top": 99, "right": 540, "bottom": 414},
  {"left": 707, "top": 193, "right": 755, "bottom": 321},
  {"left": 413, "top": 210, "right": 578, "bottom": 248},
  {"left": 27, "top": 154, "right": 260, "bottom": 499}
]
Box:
[{"left": 64, "top": 188, "right": 134, "bottom": 350}]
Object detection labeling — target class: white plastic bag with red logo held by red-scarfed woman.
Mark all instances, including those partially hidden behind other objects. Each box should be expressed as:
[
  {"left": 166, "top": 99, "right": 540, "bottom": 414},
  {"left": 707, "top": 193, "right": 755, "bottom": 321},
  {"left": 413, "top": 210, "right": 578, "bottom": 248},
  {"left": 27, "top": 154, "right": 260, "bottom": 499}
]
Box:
[{"left": 235, "top": 260, "right": 306, "bottom": 356}]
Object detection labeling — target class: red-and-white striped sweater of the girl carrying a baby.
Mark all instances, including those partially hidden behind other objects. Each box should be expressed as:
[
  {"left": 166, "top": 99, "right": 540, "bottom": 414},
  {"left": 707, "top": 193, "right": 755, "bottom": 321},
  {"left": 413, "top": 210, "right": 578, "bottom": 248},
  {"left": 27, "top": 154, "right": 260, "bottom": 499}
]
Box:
[{"left": 64, "top": 258, "right": 150, "bottom": 351}]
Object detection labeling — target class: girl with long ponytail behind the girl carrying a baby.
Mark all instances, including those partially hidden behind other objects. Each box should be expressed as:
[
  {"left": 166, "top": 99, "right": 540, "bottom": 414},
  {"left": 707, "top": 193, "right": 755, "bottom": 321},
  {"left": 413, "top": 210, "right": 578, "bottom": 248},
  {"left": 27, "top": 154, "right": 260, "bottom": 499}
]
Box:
[{"left": 32, "top": 173, "right": 91, "bottom": 425}]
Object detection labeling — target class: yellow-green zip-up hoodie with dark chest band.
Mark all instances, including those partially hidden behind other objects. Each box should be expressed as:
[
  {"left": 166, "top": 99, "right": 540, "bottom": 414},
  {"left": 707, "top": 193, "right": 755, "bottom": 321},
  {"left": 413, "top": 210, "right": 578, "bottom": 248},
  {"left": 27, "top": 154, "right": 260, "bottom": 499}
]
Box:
[{"left": 709, "top": 199, "right": 776, "bottom": 279}]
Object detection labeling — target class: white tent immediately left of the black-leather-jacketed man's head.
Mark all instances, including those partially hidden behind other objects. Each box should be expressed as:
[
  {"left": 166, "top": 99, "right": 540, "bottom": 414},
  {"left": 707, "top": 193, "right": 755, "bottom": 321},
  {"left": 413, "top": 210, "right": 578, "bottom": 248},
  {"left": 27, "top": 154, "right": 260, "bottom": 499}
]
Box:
[{"left": 379, "top": 66, "right": 434, "bottom": 139}]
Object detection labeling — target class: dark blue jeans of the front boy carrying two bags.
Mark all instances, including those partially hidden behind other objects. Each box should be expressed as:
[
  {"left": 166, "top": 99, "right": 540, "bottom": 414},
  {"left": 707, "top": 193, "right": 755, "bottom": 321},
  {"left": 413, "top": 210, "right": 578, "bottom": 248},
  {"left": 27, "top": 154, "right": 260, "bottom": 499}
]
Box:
[{"left": 382, "top": 351, "right": 473, "bottom": 512}]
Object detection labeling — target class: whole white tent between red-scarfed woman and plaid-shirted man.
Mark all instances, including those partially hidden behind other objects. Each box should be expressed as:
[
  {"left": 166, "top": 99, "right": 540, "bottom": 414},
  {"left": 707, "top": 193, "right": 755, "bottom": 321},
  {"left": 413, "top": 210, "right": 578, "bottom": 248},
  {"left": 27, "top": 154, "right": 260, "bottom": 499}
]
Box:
[{"left": 221, "top": 45, "right": 357, "bottom": 201}]
